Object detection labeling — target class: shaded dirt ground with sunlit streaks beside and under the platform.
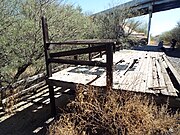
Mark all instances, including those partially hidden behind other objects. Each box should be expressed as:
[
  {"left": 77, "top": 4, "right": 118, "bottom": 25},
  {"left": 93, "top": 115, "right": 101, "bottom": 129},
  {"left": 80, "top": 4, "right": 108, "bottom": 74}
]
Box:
[{"left": 0, "top": 90, "right": 74, "bottom": 135}]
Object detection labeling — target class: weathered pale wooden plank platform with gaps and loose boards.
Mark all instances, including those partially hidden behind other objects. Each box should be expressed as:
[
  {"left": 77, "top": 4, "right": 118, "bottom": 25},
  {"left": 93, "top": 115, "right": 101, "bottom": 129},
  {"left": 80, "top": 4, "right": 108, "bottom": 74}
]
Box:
[{"left": 49, "top": 50, "right": 180, "bottom": 96}]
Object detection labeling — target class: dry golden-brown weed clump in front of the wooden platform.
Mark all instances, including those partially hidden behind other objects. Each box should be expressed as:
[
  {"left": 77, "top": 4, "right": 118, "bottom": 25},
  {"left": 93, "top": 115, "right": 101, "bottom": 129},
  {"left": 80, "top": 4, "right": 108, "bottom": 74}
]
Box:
[{"left": 49, "top": 86, "right": 180, "bottom": 135}]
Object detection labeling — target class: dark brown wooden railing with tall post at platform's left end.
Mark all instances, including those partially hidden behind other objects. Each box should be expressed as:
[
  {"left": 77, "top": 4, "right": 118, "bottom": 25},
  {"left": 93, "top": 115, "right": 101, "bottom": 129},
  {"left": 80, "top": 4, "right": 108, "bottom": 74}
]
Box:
[{"left": 42, "top": 17, "right": 117, "bottom": 115}]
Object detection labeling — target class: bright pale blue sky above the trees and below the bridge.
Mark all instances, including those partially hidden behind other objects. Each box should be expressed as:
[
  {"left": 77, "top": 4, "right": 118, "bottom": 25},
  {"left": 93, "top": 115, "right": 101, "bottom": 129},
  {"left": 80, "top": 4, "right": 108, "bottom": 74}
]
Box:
[{"left": 66, "top": 0, "right": 180, "bottom": 36}]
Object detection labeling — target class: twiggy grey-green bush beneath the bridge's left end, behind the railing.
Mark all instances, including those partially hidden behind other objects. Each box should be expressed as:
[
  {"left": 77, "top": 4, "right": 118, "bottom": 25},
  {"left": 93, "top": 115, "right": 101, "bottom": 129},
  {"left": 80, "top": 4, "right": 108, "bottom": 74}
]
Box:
[{"left": 94, "top": 7, "right": 143, "bottom": 48}]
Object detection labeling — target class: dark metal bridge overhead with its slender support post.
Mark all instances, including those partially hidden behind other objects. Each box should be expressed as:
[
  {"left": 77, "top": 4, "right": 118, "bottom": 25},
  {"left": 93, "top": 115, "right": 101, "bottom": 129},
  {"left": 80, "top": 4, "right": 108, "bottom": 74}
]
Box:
[{"left": 93, "top": 0, "right": 180, "bottom": 43}]
